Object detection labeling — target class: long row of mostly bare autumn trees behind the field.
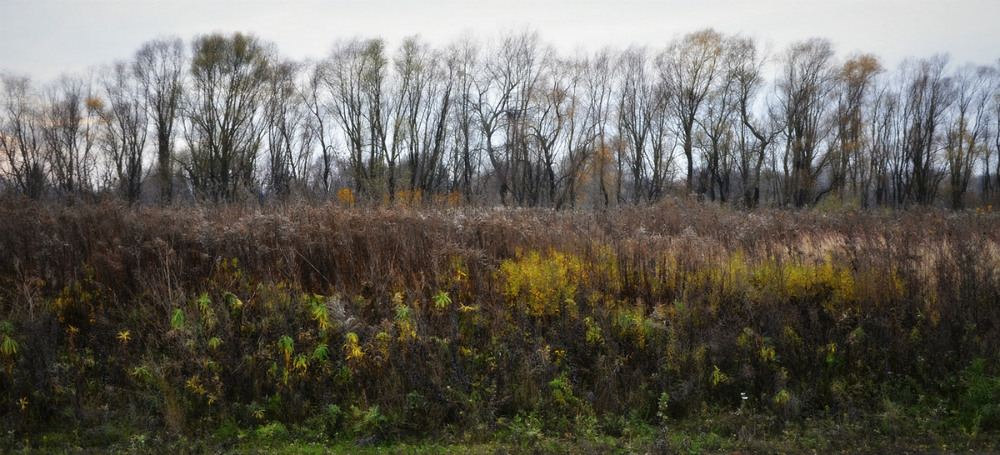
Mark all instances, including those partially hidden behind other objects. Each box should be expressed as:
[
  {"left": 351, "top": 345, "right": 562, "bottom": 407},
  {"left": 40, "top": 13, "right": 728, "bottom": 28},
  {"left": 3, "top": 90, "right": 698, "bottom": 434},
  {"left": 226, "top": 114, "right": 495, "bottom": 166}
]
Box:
[{"left": 0, "top": 29, "right": 1000, "bottom": 208}]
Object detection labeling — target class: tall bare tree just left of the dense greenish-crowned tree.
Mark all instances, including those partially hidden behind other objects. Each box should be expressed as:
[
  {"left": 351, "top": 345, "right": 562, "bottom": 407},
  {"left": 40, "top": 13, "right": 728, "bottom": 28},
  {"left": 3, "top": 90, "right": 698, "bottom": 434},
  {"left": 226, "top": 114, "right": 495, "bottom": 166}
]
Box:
[{"left": 132, "top": 38, "right": 184, "bottom": 203}]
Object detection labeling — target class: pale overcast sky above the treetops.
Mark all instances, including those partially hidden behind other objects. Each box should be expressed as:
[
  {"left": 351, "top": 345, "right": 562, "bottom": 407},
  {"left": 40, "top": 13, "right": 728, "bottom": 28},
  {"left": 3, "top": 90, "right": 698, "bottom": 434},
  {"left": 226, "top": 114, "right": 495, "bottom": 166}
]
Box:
[{"left": 0, "top": 0, "right": 1000, "bottom": 82}]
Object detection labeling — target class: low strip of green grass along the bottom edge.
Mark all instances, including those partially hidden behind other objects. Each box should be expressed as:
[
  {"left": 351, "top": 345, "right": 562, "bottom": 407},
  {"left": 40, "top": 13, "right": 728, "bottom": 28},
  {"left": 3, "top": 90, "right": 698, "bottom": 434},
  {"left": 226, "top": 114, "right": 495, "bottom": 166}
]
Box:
[{"left": 5, "top": 410, "right": 1000, "bottom": 455}]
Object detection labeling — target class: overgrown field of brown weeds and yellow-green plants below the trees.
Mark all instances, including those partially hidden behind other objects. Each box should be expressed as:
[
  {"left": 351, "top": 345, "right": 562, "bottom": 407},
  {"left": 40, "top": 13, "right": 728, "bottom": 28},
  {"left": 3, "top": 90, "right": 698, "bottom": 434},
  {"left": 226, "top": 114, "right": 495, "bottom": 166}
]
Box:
[{"left": 0, "top": 198, "right": 1000, "bottom": 453}]
